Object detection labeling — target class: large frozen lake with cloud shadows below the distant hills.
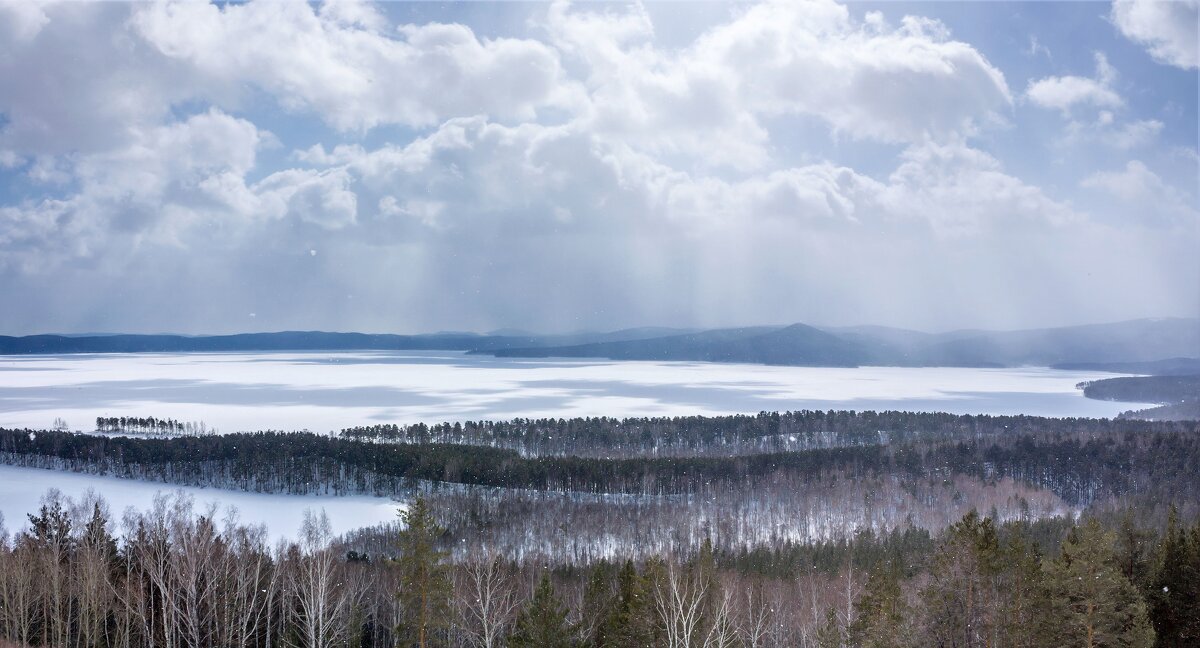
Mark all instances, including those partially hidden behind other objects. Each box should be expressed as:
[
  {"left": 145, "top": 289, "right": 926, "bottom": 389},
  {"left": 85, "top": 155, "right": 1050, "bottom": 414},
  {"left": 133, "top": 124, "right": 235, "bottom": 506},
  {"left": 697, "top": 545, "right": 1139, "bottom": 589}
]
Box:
[{"left": 0, "top": 352, "right": 1141, "bottom": 432}]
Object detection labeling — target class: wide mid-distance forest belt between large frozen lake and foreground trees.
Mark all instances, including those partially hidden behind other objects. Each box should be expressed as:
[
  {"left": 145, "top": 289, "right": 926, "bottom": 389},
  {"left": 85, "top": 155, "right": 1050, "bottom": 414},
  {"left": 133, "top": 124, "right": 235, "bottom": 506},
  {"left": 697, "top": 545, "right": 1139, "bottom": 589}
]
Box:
[{"left": 0, "top": 412, "right": 1200, "bottom": 564}]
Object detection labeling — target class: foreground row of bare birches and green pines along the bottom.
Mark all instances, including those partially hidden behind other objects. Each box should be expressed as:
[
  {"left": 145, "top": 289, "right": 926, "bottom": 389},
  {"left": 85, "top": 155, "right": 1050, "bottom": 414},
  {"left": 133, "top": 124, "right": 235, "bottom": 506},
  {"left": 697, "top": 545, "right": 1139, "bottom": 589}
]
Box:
[{"left": 0, "top": 492, "right": 1200, "bottom": 648}]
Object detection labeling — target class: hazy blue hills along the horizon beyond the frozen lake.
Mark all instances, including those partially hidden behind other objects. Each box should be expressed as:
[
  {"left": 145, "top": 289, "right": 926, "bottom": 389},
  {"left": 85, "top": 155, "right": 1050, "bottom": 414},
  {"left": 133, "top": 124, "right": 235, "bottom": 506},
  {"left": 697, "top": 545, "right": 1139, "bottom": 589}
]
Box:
[{"left": 0, "top": 318, "right": 1200, "bottom": 373}]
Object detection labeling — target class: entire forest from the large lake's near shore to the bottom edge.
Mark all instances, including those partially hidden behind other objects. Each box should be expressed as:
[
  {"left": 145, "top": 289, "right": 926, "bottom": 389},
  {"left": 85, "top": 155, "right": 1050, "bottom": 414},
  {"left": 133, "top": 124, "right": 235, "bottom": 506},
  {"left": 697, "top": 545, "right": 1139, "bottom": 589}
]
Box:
[{"left": 0, "top": 412, "right": 1200, "bottom": 648}]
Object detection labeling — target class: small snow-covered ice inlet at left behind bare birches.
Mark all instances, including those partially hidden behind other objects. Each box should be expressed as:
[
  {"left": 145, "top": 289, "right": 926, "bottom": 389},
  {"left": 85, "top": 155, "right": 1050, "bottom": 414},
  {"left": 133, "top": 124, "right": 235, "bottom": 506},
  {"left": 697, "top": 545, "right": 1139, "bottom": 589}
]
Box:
[{"left": 0, "top": 464, "right": 398, "bottom": 544}]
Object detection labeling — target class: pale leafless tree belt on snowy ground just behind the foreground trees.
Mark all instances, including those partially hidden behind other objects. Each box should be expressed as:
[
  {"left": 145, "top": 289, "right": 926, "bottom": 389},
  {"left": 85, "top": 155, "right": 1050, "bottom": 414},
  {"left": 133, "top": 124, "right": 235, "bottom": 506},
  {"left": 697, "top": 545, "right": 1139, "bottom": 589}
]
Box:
[{"left": 353, "top": 475, "right": 1070, "bottom": 565}]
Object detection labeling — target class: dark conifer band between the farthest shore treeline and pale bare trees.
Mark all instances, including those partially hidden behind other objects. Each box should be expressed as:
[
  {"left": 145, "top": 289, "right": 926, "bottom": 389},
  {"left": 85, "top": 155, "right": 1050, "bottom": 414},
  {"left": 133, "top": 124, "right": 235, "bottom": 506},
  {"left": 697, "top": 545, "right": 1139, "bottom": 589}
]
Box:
[{"left": 0, "top": 419, "right": 1200, "bottom": 505}]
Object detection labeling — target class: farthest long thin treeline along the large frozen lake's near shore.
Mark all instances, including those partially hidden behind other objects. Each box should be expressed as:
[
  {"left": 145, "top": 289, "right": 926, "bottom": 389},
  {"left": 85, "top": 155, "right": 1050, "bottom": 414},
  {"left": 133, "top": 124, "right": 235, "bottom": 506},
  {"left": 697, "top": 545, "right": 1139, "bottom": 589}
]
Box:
[{"left": 341, "top": 410, "right": 1190, "bottom": 458}]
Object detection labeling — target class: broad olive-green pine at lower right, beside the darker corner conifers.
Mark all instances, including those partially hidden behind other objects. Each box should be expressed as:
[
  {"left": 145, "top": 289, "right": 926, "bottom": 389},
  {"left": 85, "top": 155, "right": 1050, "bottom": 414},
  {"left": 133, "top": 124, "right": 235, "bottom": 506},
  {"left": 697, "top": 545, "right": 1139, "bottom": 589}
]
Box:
[{"left": 1046, "top": 520, "right": 1154, "bottom": 648}]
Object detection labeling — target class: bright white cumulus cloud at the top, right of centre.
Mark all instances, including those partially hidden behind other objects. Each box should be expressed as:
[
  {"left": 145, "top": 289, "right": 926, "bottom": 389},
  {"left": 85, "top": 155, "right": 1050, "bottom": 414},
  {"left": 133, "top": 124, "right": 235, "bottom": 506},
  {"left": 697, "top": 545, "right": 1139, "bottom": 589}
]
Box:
[{"left": 546, "top": 0, "right": 1012, "bottom": 169}]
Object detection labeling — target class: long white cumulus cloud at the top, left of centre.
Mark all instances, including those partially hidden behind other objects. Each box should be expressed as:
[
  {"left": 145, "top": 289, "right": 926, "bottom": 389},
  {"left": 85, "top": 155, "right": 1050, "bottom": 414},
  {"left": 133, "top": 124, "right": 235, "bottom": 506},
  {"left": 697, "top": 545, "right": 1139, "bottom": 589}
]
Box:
[{"left": 133, "top": 1, "right": 571, "bottom": 130}]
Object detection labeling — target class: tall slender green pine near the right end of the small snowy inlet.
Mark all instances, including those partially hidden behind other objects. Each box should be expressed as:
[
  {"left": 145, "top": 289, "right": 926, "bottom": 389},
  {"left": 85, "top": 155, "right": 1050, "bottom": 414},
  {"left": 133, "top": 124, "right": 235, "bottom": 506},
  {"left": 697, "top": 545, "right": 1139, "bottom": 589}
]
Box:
[{"left": 396, "top": 496, "right": 451, "bottom": 648}]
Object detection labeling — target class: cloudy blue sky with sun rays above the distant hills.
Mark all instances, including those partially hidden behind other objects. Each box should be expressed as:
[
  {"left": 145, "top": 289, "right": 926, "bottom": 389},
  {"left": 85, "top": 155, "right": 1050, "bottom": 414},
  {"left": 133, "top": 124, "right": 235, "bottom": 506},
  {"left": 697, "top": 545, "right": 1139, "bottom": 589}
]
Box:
[{"left": 0, "top": 0, "right": 1200, "bottom": 335}]
